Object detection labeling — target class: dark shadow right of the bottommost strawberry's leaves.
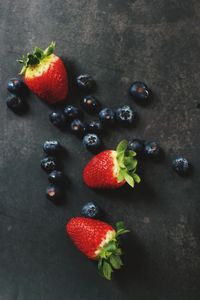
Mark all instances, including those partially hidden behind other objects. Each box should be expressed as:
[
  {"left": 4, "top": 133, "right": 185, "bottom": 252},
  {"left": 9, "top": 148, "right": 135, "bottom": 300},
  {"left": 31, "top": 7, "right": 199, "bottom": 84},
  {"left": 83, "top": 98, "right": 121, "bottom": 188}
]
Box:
[{"left": 113, "top": 232, "right": 148, "bottom": 289}]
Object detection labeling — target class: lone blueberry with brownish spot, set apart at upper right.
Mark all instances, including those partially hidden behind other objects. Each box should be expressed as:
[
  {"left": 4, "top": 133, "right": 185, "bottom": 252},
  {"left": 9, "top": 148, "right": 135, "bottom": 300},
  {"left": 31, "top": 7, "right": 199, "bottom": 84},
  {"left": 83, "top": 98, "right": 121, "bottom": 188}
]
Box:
[{"left": 130, "top": 81, "right": 150, "bottom": 104}]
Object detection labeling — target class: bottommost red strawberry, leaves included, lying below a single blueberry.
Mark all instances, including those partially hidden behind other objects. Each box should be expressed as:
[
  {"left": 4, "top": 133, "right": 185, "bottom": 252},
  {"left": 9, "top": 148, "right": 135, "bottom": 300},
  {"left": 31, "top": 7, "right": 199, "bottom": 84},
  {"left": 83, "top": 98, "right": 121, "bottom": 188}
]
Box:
[{"left": 66, "top": 217, "right": 129, "bottom": 280}]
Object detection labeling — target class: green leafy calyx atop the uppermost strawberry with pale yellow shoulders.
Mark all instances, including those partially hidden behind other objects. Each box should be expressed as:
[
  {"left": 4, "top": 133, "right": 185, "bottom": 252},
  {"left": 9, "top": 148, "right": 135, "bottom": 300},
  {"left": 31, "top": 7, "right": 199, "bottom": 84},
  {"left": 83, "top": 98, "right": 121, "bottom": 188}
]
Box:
[{"left": 17, "top": 42, "right": 56, "bottom": 75}]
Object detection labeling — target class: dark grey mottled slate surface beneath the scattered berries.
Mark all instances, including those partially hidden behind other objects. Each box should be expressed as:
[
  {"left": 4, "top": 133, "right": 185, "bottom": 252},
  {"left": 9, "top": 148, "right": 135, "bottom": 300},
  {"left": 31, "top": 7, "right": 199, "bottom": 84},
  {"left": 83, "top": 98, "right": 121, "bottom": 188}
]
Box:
[{"left": 0, "top": 0, "right": 200, "bottom": 300}]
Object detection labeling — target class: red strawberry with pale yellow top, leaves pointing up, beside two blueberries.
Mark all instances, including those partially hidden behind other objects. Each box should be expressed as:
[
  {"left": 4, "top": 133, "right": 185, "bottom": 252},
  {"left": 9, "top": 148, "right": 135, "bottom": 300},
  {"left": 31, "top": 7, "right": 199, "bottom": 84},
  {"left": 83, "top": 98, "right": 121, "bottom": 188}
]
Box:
[{"left": 18, "top": 42, "right": 68, "bottom": 103}]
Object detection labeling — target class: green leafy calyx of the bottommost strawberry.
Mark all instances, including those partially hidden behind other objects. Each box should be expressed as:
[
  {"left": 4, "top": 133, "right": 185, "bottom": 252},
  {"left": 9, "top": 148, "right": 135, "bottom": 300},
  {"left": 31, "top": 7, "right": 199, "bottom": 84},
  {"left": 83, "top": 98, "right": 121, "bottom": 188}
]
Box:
[{"left": 98, "top": 222, "right": 130, "bottom": 280}]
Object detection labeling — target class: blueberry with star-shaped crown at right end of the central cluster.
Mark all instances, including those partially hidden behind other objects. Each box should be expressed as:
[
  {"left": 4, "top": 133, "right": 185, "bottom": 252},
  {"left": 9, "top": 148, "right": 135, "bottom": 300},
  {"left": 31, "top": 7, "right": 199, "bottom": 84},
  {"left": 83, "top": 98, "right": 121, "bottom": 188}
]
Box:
[{"left": 115, "top": 105, "right": 135, "bottom": 125}]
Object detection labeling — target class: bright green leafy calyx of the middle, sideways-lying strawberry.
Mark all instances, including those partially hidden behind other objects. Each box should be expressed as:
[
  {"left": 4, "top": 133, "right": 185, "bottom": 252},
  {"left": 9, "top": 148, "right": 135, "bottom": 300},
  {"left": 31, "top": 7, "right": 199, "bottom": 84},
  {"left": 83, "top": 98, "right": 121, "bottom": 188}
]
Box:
[{"left": 116, "top": 140, "right": 141, "bottom": 188}]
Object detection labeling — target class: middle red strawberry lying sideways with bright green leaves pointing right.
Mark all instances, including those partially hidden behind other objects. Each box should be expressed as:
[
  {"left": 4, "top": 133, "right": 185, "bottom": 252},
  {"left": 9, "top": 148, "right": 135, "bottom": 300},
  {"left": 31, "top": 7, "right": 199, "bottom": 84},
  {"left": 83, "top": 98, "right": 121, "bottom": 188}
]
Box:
[{"left": 83, "top": 140, "right": 140, "bottom": 189}]
